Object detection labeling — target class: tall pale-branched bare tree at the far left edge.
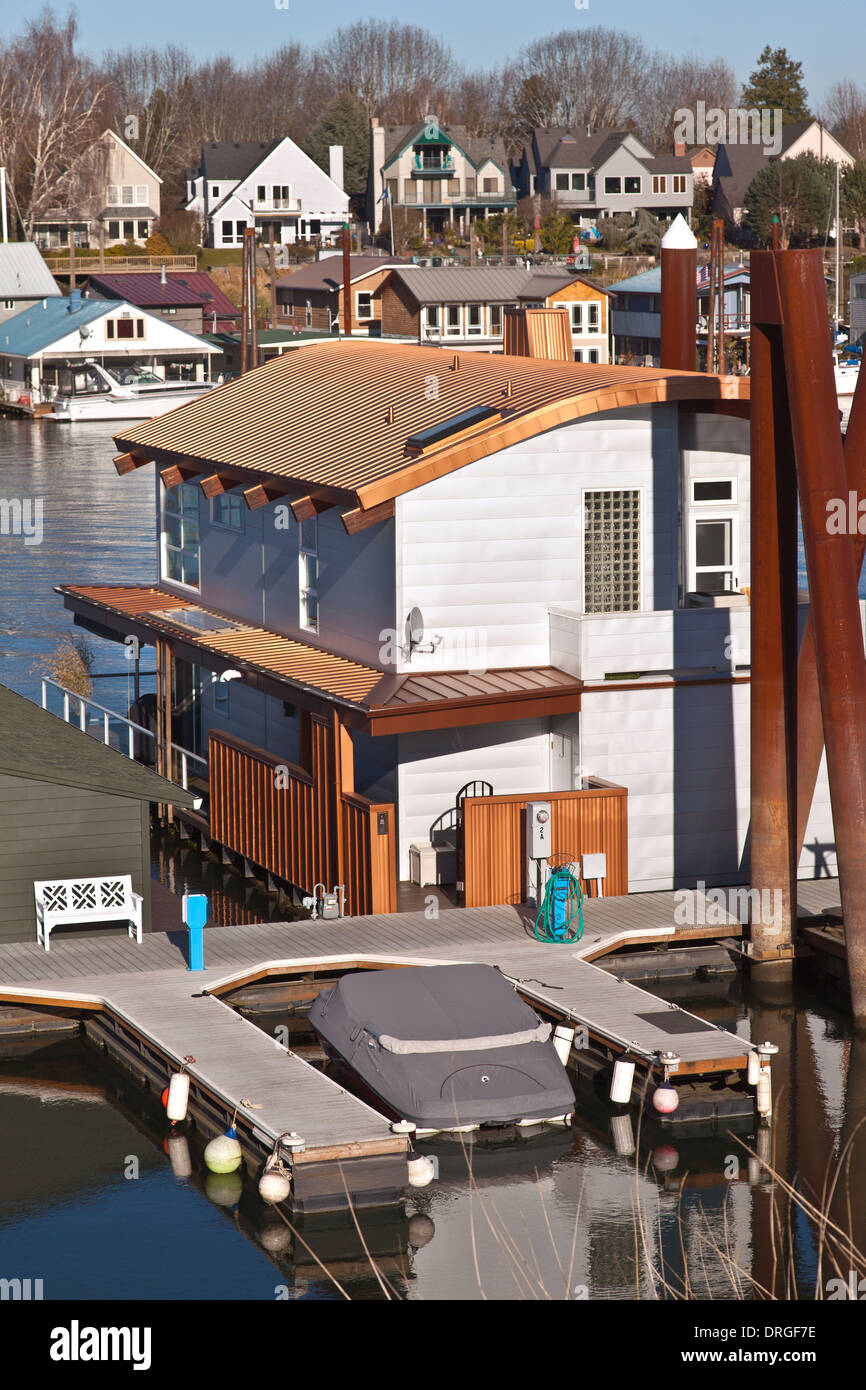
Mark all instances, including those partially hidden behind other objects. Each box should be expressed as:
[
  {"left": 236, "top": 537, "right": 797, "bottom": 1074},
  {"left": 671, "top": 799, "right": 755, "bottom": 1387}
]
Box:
[{"left": 0, "top": 10, "right": 106, "bottom": 239}]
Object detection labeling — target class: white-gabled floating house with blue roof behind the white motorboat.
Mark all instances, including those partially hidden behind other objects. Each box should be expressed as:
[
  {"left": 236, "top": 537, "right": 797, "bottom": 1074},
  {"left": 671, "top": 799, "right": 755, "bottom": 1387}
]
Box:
[{"left": 0, "top": 289, "right": 218, "bottom": 404}]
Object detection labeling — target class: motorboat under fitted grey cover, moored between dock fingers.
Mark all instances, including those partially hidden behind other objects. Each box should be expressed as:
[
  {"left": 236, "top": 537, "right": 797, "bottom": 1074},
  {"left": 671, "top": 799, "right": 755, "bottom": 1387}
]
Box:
[{"left": 310, "top": 965, "right": 574, "bottom": 1130}]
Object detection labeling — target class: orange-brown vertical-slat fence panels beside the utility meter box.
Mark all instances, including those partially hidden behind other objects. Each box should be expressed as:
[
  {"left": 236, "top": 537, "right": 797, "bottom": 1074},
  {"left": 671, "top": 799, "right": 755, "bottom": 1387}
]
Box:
[{"left": 463, "top": 778, "right": 628, "bottom": 908}]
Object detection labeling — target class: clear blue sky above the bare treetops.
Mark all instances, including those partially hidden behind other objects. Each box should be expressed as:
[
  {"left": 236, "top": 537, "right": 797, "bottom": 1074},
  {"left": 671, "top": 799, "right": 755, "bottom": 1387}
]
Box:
[{"left": 0, "top": 0, "right": 866, "bottom": 106}]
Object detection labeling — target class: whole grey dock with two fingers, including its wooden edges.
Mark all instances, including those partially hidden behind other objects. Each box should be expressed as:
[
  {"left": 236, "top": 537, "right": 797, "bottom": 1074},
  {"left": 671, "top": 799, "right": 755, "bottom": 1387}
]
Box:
[{"left": 0, "top": 892, "right": 767, "bottom": 1195}]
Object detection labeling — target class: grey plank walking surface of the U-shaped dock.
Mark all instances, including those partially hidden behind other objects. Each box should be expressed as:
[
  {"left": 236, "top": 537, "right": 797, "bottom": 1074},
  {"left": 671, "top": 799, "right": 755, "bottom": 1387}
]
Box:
[{"left": 0, "top": 880, "right": 783, "bottom": 1154}]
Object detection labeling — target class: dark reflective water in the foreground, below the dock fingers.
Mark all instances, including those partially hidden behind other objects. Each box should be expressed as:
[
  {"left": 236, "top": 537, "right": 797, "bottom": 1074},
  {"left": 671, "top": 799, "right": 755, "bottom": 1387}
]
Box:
[{"left": 0, "top": 977, "right": 866, "bottom": 1300}]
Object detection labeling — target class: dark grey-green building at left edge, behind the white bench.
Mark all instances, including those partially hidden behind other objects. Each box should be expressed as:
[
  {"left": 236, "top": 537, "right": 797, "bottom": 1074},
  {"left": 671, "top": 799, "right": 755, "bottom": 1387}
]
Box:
[{"left": 0, "top": 685, "right": 193, "bottom": 944}]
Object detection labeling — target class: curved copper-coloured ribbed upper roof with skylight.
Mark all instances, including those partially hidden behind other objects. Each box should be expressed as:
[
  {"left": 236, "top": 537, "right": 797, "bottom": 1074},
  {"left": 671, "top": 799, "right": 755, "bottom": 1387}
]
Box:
[{"left": 115, "top": 339, "right": 749, "bottom": 507}]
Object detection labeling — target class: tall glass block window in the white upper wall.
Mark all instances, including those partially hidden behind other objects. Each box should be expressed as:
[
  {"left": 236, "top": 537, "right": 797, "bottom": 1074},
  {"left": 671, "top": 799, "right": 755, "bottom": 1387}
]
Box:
[{"left": 584, "top": 488, "right": 641, "bottom": 613}]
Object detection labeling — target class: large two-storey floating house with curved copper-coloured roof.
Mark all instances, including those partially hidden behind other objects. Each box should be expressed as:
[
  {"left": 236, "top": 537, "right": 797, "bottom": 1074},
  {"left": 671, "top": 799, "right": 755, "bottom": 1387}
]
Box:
[{"left": 55, "top": 336, "right": 834, "bottom": 912}]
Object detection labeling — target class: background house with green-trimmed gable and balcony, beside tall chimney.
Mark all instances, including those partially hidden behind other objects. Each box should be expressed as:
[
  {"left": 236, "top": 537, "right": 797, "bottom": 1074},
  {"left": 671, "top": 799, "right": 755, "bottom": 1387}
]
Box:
[{"left": 367, "top": 115, "right": 517, "bottom": 238}]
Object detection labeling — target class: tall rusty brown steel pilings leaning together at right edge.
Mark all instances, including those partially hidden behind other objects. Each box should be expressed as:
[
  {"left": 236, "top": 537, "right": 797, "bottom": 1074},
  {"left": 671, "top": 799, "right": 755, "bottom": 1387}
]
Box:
[{"left": 751, "top": 250, "right": 866, "bottom": 1011}]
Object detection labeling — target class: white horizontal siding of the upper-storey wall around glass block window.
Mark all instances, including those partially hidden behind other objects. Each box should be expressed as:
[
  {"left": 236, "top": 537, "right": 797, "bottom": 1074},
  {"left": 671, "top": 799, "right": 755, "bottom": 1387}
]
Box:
[{"left": 396, "top": 406, "right": 678, "bottom": 671}]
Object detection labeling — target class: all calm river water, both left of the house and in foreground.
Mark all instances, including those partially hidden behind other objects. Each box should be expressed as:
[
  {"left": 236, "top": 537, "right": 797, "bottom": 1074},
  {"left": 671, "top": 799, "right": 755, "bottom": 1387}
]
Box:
[{"left": 0, "top": 420, "right": 866, "bottom": 1300}]
